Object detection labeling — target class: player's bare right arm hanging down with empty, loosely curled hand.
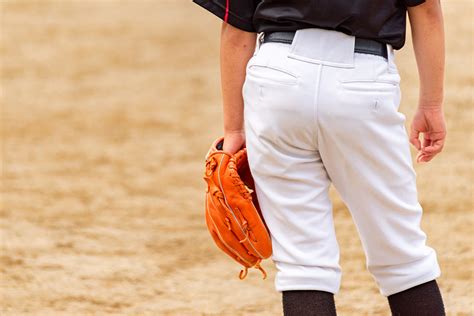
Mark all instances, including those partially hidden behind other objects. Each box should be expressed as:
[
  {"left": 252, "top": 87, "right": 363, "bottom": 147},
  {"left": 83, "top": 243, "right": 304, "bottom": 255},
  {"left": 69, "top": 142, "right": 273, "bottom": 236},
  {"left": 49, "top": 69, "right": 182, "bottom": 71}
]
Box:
[{"left": 408, "top": 0, "right": 446, "bottom": 162}]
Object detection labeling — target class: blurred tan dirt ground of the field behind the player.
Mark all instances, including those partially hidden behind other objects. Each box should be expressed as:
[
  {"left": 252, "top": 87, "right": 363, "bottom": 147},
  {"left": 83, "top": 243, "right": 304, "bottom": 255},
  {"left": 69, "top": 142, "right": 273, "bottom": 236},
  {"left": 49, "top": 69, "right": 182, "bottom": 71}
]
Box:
[{"left": 0, "top": 0, "right": 474, "bottom": 315}]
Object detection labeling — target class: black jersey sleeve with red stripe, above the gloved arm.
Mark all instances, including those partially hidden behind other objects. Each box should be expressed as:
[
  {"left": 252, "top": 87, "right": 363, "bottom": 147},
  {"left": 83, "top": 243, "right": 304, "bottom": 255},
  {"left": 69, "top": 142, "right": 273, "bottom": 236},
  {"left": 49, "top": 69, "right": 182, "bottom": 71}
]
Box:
[{"left": 193, "top": 0, "right": 261, "bottom": 32}]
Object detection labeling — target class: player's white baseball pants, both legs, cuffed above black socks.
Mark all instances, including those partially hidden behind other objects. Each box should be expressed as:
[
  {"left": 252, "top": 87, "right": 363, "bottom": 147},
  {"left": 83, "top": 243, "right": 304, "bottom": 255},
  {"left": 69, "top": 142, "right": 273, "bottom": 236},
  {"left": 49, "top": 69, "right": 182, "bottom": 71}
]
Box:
[{"left": 242, "top": 28, "right": 440, "bottom": 296}]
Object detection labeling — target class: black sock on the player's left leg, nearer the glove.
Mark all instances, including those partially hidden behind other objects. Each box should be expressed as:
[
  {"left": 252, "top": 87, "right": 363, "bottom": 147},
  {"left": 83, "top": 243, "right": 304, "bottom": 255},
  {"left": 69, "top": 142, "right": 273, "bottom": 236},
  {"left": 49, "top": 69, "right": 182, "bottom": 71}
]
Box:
[{"left": 282, "top": 290, "right": 336, "bottom": 316}]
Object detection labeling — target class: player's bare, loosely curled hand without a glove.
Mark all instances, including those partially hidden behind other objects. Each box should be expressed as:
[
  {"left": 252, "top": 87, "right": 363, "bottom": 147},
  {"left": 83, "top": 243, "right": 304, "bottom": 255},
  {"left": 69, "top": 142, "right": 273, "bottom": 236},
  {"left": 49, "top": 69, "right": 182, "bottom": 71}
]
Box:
[{"left": 410, "top": 106, "right": 446, "bottom": 162}]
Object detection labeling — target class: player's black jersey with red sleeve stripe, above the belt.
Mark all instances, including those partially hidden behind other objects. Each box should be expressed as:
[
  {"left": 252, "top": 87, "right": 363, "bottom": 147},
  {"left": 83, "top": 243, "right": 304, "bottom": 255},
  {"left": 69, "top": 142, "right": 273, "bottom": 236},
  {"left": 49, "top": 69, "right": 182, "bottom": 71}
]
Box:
[{"left": 193, "top": 0, "right": 425, "bottom": 49}]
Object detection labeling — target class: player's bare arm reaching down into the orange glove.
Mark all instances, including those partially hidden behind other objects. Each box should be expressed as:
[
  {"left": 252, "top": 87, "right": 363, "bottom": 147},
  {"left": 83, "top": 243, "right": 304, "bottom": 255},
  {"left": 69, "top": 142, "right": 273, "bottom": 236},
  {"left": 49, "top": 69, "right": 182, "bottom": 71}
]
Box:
[{"left": 220, "top": 22, "right": 257, "bottom": 153}]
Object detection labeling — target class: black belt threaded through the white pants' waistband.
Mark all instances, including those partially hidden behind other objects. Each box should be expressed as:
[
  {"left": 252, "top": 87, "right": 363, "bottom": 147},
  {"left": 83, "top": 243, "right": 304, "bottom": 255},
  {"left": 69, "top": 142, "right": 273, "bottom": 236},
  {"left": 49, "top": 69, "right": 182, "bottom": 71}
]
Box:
[{"left": 263, "top": 32, "right": 387, "bottom": 58}]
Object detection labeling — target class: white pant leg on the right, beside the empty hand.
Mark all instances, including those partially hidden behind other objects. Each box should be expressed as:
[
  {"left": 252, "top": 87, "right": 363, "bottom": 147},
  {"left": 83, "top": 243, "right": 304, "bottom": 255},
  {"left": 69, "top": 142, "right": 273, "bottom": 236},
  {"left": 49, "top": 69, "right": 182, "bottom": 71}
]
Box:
[{"left": 318, "top": 52, "right": 440, "bottom": 315}]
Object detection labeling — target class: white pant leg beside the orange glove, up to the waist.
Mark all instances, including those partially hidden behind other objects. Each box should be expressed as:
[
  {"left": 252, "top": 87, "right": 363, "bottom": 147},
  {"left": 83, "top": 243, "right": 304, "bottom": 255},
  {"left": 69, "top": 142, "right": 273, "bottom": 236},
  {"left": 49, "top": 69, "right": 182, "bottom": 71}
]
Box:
[{"left": 243, "top": 43, "right": 341, "bottom": 302}]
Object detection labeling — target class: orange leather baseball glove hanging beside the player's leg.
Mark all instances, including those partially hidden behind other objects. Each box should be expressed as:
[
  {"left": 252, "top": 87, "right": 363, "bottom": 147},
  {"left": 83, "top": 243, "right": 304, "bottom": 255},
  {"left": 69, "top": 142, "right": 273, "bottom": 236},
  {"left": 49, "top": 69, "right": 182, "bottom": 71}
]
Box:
[{"left": 204, "top": 137, "right": 272, "bottom": 279}]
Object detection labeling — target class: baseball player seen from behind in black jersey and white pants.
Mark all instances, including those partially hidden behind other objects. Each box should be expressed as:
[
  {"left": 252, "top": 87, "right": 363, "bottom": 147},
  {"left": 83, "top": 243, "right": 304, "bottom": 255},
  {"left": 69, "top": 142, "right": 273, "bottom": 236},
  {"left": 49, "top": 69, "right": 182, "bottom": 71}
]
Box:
[{"left": 193, "top": 0, "right": 446, "bottom": 316}]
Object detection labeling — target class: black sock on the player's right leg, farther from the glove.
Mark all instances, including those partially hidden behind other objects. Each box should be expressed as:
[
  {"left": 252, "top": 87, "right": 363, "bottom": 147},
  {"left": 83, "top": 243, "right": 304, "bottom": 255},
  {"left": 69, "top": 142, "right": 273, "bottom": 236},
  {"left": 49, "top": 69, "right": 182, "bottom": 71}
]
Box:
[{"left": 388, "top": 280, "right": 446, "bottom": 316}]
